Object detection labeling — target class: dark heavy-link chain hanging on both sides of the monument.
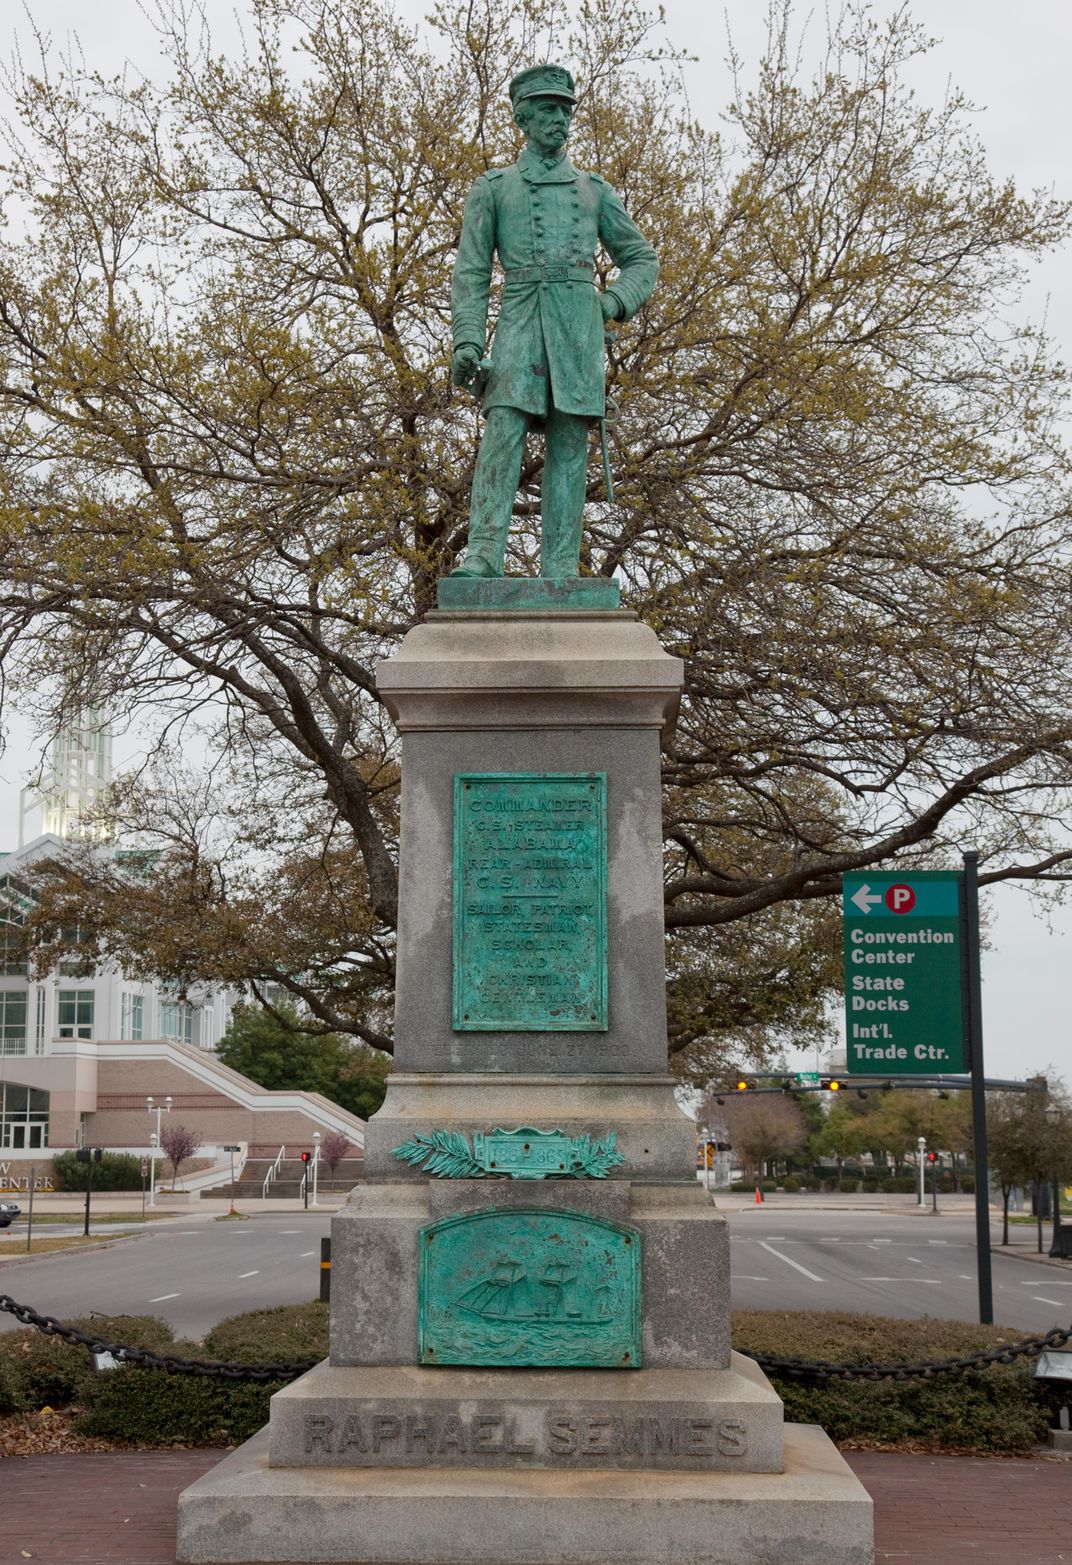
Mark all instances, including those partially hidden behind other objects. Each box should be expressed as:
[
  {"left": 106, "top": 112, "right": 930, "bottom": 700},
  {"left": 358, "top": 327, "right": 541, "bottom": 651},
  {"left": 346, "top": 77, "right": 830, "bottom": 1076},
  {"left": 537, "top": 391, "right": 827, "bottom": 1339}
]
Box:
[{"left": 0, "top": 1293, "right": 1072, "bottom": 1382}]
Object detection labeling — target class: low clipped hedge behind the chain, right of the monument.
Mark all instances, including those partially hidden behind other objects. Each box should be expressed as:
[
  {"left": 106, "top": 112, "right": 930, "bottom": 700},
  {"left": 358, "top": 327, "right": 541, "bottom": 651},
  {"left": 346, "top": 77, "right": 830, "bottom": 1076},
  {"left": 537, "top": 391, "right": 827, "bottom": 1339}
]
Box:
[{"left": 732, "top": 1310, "right": 1050, "bottom": 1455}]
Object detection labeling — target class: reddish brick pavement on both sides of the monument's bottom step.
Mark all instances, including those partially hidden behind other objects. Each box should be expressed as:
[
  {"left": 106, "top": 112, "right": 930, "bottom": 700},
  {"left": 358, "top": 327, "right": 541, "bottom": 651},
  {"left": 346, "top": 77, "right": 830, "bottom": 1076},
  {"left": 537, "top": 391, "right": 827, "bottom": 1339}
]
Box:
[{"left": 0, "top": 1451, "right": 1072, "bottom": 1565}]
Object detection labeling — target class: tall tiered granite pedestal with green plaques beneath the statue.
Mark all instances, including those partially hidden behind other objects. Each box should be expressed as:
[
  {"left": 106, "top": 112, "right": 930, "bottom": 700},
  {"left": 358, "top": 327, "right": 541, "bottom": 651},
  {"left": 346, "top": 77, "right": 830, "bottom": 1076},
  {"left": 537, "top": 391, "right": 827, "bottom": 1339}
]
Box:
[{"left": 178, "top": 581, "right": 873, "bottom": 1565}]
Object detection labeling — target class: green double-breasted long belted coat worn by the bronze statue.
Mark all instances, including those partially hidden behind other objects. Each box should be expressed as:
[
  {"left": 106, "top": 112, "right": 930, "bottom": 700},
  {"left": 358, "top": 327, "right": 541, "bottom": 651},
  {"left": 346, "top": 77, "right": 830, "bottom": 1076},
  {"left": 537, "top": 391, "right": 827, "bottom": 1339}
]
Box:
[{"left": 452, "top": 149, "right": 659, "bottom": 418}]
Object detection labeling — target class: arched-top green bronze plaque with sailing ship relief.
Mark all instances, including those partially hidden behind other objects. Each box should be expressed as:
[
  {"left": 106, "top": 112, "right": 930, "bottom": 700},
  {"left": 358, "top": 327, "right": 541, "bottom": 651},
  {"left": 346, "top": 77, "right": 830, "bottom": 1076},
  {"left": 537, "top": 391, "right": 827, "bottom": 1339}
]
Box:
[{"left": 418, "top": 1208, "right": 642, "bottom": 1369}]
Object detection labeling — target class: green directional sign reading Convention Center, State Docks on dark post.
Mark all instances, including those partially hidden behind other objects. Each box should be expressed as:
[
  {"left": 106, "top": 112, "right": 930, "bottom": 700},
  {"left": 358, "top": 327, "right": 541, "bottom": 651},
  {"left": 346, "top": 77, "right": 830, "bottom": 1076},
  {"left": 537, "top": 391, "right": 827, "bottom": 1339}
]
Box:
[{"left": 842, "top": 870, "right": 967, "bottom": 1075}]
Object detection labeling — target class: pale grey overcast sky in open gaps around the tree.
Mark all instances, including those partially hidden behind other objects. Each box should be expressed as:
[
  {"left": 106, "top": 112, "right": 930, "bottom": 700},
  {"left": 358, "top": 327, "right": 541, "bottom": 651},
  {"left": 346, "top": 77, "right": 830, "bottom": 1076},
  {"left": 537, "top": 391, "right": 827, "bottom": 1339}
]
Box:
[{"left": 0, "top": 0, "right": 1072, "bottom": 1078}]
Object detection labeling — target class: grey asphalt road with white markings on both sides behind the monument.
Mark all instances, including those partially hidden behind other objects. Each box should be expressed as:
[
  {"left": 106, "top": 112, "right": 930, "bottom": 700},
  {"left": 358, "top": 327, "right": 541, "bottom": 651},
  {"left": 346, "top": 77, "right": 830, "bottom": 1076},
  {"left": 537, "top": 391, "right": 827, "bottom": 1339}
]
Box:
[{"left": 0, "top": 1207, "right": 1072, "bottom": 1340}]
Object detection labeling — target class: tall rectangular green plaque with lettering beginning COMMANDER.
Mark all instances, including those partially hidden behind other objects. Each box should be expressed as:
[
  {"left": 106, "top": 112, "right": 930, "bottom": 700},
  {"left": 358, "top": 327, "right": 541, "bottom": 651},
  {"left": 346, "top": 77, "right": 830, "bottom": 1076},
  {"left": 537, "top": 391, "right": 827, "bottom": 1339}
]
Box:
[{"left": 454, "top": 772, "right": 607, "bottom": 1033}]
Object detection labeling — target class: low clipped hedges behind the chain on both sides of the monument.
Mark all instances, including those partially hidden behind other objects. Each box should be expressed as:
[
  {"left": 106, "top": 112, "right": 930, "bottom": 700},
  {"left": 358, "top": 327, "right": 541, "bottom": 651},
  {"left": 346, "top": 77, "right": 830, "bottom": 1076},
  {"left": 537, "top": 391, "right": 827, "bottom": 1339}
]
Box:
[{"left": 0, "top": 1304, "right": 1055, "bottom": 1455}]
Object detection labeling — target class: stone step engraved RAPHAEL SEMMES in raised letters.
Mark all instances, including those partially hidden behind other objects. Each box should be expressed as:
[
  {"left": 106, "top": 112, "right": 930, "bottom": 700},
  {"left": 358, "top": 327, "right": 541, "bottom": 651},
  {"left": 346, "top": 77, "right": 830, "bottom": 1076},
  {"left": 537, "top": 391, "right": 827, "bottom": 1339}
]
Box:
[{"left": 269, "top": 1354, "right": 782, "bottom": 1474}]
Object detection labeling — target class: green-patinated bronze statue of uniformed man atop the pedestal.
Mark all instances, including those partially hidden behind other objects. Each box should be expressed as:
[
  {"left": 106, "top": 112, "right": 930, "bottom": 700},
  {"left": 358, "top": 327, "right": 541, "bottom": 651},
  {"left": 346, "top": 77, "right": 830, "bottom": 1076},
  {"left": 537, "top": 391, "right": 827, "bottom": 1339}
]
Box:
[{"left": 451, "top": 66, "right": 659, "bottom": 579}]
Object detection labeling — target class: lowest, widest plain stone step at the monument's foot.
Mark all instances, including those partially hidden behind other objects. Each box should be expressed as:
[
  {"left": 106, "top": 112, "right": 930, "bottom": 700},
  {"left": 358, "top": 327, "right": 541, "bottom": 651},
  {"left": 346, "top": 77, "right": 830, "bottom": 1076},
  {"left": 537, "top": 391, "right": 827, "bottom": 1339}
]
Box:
[{"left": 177, "top": 1424, "right": 875, "bottom": 1565}]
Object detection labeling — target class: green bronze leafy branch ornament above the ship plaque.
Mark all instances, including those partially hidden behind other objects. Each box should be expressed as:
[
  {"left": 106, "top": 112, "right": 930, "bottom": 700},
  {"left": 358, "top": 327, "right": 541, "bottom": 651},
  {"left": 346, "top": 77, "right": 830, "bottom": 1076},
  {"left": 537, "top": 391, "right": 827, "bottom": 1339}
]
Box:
[{"left": 391, "top": 1125, "right": 624, "bottom": 1178}]
